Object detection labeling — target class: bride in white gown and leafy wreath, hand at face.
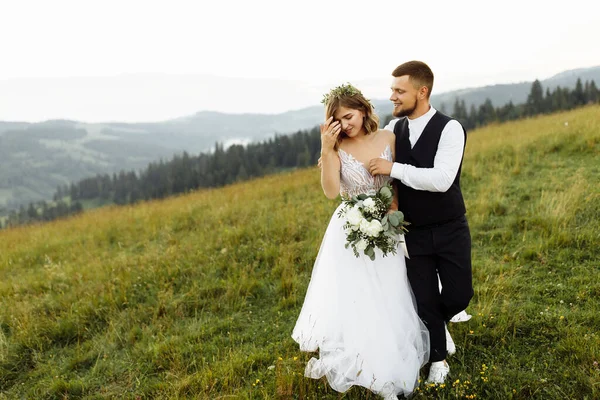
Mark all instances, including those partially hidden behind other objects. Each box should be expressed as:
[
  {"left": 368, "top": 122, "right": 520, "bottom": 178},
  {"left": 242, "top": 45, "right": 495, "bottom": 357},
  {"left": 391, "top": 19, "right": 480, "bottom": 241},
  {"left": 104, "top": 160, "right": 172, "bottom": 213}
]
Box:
[{"left": 292, "top": 84, "right": 429, "bottom": 399}]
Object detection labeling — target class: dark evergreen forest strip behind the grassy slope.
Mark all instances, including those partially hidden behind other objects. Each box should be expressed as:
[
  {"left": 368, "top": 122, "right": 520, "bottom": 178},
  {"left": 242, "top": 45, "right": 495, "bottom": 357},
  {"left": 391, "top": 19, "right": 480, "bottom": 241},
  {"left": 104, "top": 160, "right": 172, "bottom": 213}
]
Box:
[{"left": 0, "top": 79, "right": 600, "bottom": 228}]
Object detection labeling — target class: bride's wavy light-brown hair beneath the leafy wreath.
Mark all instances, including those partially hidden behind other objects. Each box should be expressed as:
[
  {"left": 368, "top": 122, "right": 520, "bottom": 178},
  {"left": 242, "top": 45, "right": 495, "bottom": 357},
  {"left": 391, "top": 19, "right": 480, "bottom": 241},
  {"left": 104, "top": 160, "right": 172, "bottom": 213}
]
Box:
[{"left": 323, "top": 84, "right": 379, "bottom": 150}]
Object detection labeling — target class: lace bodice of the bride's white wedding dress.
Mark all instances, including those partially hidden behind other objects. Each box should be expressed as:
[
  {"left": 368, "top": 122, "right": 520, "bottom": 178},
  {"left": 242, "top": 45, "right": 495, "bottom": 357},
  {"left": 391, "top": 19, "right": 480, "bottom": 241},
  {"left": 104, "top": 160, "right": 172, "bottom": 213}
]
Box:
[{"left": 338, "top": 145, "right": 393, "bottom": 196}]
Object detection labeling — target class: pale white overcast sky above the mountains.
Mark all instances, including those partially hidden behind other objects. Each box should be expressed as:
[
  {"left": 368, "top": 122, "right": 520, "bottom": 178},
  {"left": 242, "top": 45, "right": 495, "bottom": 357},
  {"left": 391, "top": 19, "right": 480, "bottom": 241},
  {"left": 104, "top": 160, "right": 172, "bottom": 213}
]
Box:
[{"left": 0, "top": 0, "right": 600, "bottom": 122}]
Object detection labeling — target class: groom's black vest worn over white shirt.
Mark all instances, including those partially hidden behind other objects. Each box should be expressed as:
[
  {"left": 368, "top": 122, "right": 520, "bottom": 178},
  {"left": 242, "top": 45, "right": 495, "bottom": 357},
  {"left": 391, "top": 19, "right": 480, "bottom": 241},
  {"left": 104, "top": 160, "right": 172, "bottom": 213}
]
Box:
[{"left": 394, "top": 111, "right": 467, "bottom": 230}]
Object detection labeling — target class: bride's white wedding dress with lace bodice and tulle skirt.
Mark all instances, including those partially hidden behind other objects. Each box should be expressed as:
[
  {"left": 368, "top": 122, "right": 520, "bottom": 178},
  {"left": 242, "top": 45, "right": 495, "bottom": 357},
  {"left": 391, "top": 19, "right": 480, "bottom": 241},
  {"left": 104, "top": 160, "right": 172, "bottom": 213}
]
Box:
[{"left": 292, "top": 146, "right": 429, "bottom": 398}]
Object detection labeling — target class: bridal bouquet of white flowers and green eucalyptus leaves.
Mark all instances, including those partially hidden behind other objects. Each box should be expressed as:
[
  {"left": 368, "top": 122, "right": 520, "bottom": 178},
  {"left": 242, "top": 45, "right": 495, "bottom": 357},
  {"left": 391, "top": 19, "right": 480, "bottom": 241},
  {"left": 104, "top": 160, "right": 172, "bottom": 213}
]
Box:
[{"left": 338, "top": 184, "right": 408, "bottom": 260}]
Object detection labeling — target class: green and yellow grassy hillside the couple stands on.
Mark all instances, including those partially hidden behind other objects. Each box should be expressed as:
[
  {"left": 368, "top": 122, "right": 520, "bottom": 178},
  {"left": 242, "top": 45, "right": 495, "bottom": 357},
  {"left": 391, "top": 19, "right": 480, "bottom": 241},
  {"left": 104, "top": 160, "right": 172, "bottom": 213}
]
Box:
[{"left": 0, "top": 106, "right": 600, "bottom": 399}]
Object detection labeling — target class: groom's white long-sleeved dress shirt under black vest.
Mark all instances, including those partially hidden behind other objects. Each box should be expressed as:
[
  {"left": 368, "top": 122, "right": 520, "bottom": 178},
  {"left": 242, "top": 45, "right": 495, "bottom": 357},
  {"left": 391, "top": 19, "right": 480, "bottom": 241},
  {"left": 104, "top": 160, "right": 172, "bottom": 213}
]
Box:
[{"left": 383, "top": 107, "right": 465, "bottom": 192}]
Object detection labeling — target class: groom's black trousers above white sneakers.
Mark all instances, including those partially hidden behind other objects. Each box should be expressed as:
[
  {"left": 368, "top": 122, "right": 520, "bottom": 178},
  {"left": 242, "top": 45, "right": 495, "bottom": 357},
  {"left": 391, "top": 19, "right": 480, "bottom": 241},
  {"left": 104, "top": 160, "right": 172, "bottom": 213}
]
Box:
[{"left": 405, "top": 216, "right": 473, "bottom": 362}]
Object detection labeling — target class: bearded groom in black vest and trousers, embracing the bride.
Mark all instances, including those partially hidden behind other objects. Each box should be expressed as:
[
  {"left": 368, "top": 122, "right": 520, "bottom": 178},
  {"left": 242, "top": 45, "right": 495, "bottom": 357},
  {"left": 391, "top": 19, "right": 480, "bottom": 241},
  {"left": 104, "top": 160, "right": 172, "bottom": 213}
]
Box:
[{"left": 369, "top": 61, "right": 473, "bottom": 383}]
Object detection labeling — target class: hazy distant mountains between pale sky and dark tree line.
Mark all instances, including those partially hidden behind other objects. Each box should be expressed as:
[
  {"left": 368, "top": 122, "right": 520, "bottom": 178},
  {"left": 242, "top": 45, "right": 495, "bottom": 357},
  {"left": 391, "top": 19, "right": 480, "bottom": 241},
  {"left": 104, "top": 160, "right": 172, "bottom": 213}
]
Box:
[{"left": 0, "top": 66, "right": 600, "bottom": 211}]
